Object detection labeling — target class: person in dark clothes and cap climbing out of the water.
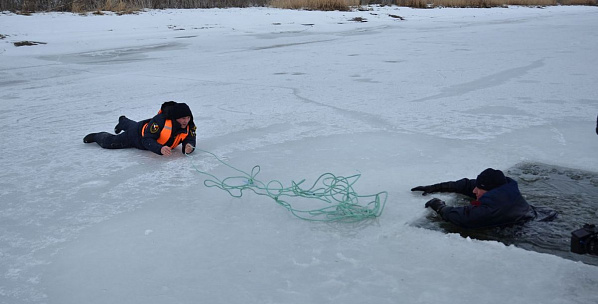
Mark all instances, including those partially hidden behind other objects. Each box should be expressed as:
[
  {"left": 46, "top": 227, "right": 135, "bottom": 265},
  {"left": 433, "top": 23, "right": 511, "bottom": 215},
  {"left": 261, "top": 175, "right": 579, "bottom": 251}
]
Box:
[{"left": 411, "top": 168, "right": 536, "bottom": 229}]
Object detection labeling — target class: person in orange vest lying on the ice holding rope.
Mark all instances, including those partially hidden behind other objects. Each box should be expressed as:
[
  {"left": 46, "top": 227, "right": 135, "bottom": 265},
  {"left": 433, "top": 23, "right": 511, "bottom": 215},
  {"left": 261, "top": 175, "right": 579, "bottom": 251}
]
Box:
[{"left": 83, "top": 101, "right": 196, "bottom": 156}]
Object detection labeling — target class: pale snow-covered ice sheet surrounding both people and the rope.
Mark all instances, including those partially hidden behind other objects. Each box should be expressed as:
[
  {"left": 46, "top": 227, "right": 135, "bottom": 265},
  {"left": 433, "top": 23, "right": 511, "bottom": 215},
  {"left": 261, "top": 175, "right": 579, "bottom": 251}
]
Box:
[{"left": 0, "top": 6, "right": 598, "bottom": 304}]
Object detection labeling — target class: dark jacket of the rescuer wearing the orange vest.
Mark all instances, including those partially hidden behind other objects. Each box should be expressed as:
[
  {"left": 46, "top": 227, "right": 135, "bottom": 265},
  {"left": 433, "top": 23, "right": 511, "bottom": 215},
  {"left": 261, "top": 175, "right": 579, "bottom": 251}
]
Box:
[{"left": 138, "top": 114, "right": 196, "bottom": 155}]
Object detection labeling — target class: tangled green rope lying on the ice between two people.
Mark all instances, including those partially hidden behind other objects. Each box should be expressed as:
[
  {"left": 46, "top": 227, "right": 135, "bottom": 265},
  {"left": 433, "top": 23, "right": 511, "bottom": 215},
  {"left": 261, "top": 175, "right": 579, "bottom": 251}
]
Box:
[{"left": 189, "top": 149, "right": 388, "bottom": 222}]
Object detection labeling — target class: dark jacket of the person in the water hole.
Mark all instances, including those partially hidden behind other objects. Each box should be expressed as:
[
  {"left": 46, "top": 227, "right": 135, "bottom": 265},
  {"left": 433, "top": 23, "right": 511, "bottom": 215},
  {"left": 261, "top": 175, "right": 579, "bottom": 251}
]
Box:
[{"left": 438, "top": 177, "right": 535, "bottom": 228}]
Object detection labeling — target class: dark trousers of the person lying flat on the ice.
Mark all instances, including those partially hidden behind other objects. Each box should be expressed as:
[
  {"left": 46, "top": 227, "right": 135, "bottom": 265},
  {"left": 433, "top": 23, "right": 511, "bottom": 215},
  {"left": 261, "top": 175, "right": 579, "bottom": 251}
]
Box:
[{"left": 95, "top": 117, "right": 145, "bottom": 150}]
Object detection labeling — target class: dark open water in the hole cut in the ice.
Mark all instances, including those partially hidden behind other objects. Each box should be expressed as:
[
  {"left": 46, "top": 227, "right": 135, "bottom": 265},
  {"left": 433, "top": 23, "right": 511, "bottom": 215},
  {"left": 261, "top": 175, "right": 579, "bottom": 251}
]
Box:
[{"left": 414, "top": 163, "right": 598, "bottom": 266}]
